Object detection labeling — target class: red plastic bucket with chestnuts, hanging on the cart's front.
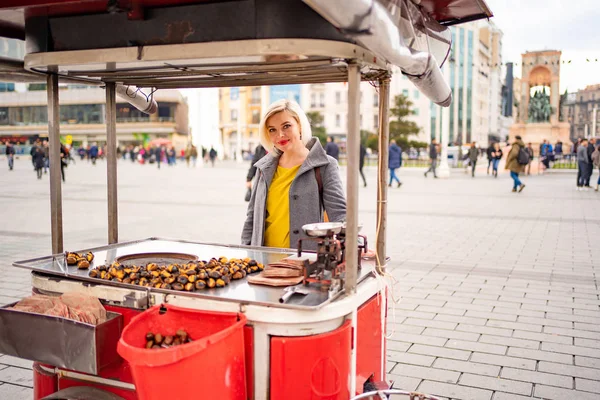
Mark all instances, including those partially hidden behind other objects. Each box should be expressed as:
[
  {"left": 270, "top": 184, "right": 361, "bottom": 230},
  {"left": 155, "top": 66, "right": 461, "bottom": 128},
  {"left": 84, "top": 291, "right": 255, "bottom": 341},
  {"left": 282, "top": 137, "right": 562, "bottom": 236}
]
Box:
[{"left": 117, "top": 305, "right": 246, "bottom": 400}]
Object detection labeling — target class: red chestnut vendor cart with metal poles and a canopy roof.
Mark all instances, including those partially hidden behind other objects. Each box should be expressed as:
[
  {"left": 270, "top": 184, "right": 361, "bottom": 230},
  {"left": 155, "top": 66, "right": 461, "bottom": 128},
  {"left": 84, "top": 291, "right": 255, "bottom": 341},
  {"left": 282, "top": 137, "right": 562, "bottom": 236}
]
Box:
[{"left": 0, "top": 0, "right": 491, "bottom": 399}]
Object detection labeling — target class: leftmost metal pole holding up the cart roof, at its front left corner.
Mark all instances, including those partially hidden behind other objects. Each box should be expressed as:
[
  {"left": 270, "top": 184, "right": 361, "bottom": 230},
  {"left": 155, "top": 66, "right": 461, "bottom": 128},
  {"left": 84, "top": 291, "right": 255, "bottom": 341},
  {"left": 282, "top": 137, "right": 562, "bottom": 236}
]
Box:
[{"left": 47, "top": 74, "right": 63, "bottom": 254}]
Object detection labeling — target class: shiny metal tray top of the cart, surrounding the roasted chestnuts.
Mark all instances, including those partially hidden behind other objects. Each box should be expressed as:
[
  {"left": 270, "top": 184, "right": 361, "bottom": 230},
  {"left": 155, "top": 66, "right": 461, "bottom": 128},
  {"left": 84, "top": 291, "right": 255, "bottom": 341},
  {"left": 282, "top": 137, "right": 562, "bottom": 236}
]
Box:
[{"left": 13, "top": 238, "right": 373, "bottom": 310}]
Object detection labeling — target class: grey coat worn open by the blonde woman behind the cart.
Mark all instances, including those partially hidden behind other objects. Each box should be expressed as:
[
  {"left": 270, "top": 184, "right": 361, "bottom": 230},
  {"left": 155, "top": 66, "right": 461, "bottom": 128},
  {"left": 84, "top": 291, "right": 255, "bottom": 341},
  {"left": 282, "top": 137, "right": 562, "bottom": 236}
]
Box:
[{"left": 242, "top": 138, "right": 346, "bottom": 249}]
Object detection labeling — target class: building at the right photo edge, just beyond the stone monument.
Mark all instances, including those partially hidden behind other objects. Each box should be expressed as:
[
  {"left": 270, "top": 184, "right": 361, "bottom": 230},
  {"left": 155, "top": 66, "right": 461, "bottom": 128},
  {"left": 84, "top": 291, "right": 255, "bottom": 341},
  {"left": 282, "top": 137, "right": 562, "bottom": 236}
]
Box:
[{"left": 561, "top": 84, "right": 600, "bottom": 142}]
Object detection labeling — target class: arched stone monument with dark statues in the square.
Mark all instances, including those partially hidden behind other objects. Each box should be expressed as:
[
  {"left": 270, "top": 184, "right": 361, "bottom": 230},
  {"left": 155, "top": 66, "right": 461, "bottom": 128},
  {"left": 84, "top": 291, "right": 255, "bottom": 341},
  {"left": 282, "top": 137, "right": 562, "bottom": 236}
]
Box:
[{"left": 509, "top": 50, "right": 570, "bottom": 152}]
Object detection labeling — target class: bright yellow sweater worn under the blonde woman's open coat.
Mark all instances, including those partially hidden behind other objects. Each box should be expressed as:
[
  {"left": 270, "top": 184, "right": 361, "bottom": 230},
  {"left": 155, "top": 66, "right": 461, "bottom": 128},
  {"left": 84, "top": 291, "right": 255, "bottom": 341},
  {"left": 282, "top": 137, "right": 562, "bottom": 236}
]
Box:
[{"left": 264, "top": 165, "right": 300, "bottom": 249}]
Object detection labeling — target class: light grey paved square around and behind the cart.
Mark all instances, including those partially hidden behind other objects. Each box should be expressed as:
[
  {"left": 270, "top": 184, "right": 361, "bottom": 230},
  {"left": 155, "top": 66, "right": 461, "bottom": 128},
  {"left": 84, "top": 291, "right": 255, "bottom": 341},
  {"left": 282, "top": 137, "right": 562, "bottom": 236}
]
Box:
[{"left": 0, "top": 160, "right": 600, "bottom": 400}]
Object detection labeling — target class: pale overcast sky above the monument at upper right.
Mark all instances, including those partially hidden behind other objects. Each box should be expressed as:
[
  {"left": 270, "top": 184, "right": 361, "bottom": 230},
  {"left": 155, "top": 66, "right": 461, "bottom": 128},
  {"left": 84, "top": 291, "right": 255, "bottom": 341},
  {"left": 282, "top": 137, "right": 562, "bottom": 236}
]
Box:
[{"left": 485, "top": 0, "right": 600, "bottom": 92}]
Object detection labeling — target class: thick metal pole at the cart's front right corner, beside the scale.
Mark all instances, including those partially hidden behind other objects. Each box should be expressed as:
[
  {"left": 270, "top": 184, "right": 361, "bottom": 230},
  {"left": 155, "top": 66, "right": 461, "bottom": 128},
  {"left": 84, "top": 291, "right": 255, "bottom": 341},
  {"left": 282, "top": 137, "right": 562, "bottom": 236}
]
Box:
[{"left": 344, "top": 64, "right": 360, "bottom": 295}]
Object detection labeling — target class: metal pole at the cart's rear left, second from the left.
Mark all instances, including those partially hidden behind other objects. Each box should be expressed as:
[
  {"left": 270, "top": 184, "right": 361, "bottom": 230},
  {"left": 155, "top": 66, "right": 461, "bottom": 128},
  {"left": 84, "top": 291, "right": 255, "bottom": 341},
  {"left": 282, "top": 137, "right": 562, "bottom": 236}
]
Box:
[{"left": 106, "top": 83, "right": 119, "bottom": 244}]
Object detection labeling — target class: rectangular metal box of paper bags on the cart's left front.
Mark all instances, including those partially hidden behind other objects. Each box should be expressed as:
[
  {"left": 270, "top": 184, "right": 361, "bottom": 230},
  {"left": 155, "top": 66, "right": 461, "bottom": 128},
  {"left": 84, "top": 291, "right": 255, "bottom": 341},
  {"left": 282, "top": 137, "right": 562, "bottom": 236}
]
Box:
[{"left": 0, "top": 303, "right": 123, "bottom": 375}]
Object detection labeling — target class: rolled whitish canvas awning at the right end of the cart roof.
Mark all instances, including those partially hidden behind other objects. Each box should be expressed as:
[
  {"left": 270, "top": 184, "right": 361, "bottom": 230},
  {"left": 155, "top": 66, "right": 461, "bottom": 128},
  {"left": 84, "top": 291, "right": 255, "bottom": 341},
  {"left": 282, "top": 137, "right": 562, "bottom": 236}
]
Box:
[{"left": 303, "top": 0, "right": 491, "bottom": 107}]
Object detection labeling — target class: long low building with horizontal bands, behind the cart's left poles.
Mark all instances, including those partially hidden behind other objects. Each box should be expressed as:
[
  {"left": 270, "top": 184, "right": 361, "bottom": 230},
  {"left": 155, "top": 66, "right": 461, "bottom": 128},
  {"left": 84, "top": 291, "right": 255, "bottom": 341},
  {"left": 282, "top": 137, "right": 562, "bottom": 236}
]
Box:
[{"left": 0, "top": 83, "right": 189, "bottom": 148}]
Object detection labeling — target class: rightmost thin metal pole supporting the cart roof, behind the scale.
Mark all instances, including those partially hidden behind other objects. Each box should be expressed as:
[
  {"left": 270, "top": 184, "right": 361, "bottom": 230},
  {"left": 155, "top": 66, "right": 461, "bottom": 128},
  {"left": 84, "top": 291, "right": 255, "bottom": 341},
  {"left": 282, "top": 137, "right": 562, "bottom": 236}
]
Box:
[{"left": 375, "top": 77, "right": 390, "bottom": 271}]
